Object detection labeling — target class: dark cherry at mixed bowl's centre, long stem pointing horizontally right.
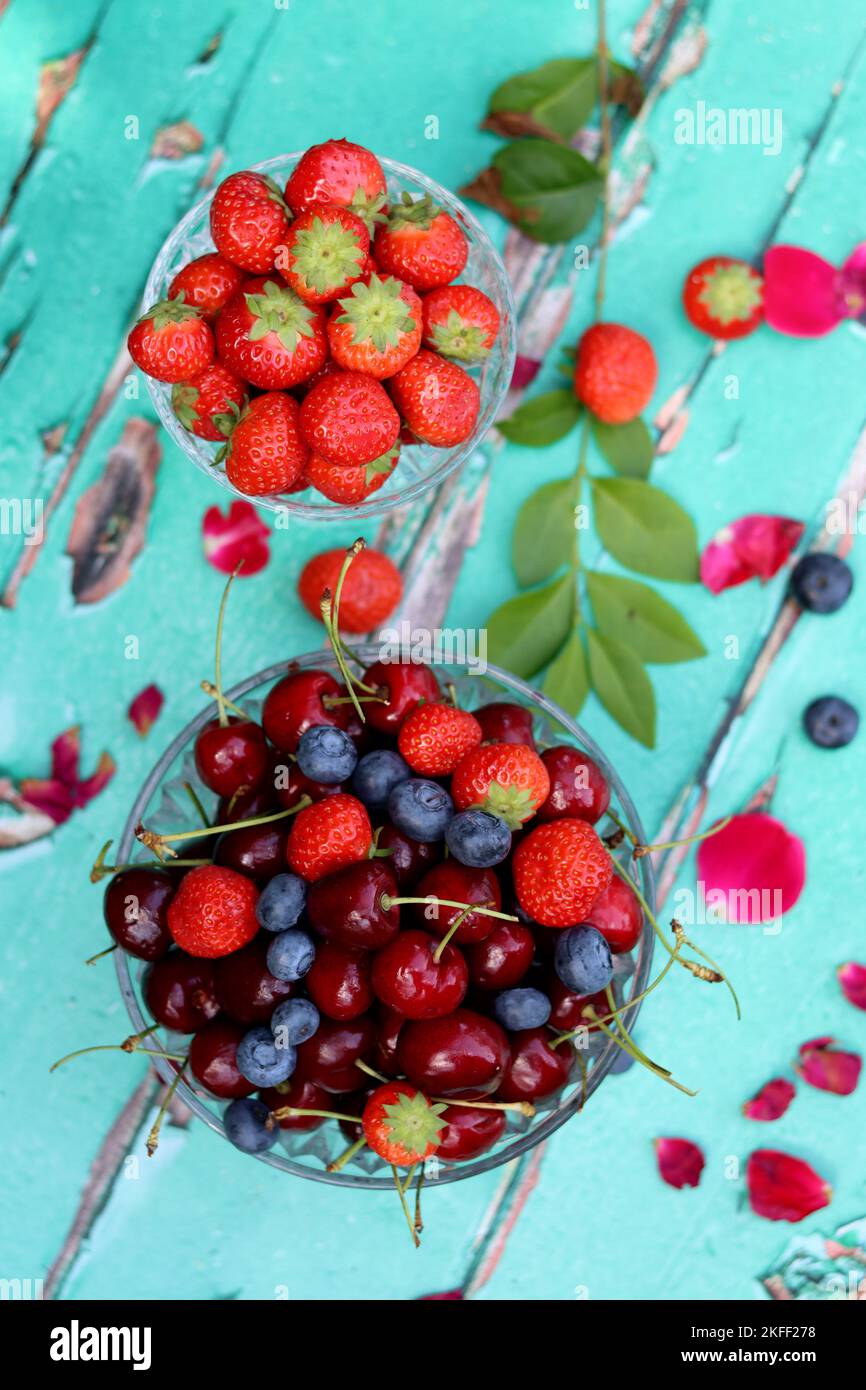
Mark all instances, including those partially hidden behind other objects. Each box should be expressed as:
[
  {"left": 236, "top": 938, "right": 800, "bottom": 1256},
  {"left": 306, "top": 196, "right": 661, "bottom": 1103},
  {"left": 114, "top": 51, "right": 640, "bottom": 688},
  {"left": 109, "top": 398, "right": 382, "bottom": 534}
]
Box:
[{"left": 307, "top": 859, "right": 400, "bottom": 951}]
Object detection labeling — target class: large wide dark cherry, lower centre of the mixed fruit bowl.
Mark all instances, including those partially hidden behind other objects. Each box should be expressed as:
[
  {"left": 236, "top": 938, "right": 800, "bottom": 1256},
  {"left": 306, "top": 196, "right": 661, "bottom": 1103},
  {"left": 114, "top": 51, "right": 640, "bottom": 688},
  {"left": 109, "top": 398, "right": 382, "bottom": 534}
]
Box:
[{"left": 398, "top": 1009, "right": 510, "bottom": 1099}]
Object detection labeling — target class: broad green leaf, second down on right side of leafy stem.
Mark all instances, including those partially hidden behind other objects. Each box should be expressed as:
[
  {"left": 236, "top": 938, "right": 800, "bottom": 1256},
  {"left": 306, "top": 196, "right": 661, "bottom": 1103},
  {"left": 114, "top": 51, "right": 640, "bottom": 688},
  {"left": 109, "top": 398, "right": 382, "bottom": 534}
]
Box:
[{"left": 592, "top": 478, "right": 698, "bottom": 584}]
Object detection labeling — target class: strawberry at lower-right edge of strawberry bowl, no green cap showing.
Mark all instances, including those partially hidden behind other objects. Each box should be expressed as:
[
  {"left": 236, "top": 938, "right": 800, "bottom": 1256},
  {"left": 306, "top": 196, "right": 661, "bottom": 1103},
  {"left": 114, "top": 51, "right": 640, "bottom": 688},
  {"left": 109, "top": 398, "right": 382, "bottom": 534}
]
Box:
[{"left": 391, "top": 348, "right": 481, "bottom": 449}]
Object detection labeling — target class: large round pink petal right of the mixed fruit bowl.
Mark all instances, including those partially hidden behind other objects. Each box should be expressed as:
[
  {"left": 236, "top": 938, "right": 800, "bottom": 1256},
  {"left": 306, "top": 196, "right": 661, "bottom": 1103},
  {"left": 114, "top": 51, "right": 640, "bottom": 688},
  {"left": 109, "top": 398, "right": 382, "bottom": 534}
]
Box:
[{"left": 698, "top": 810, "right": 806, "bottom": 923}]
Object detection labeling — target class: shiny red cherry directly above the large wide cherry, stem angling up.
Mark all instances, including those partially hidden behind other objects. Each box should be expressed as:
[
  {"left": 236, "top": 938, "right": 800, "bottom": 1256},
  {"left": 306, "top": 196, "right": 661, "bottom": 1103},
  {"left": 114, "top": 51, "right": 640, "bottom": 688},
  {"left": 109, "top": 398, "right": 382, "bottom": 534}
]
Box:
[{"left": 373, "top": 929, "right": 468, "bottom": 1019}]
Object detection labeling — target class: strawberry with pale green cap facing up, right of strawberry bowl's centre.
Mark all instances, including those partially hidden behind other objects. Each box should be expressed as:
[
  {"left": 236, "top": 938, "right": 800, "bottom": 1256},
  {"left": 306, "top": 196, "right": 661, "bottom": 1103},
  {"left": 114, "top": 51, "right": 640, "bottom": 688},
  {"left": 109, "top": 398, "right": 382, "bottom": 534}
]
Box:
[{"left": 328, "top": 275, "right": 421, "bottom": 381}]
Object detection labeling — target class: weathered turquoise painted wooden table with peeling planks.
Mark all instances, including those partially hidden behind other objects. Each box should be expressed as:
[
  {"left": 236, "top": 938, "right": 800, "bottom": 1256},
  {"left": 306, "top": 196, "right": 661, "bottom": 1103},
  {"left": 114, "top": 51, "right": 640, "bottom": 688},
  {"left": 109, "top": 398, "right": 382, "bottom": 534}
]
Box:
[{"left": 0, "top": 0, "right": 866, "bottom": 1301}]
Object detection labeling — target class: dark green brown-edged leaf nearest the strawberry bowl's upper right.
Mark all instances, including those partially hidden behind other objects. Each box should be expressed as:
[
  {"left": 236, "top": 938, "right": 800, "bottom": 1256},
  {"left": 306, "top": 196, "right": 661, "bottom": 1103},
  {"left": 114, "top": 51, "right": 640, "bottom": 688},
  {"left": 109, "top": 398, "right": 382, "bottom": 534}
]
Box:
[{"left": 493, "top": 139, "right": 602, "bottom": 242}]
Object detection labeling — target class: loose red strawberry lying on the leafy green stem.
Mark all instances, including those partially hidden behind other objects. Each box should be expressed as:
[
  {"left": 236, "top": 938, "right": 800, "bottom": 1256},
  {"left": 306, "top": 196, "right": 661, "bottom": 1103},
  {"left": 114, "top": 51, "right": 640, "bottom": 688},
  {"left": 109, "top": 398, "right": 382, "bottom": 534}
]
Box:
[{"left": 574, "top": 324, "right": 657, "bottom": 425}]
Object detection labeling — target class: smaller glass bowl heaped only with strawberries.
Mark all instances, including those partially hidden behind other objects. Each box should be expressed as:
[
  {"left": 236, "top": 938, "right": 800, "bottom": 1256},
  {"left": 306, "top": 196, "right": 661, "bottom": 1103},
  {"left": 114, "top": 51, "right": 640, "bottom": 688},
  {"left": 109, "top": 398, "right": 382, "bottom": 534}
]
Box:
[{"left": 129, "top": 140, "right": 516, "bottom": 520}]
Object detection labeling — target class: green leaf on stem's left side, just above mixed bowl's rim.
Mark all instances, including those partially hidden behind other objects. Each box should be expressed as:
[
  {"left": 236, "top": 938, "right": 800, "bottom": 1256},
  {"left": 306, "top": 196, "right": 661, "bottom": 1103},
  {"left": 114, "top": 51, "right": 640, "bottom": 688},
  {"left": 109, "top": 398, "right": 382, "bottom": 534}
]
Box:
[{"left": 487, "top": 571, "right": 574, "bottom": 676}]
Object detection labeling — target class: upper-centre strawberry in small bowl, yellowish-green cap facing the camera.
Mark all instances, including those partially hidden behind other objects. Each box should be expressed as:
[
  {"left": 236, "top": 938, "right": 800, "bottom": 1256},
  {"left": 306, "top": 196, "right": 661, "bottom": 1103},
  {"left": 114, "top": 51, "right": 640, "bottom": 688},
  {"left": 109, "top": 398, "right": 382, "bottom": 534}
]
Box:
[{"left": 278, "top": 203, "right": 370, "bottom": 304}]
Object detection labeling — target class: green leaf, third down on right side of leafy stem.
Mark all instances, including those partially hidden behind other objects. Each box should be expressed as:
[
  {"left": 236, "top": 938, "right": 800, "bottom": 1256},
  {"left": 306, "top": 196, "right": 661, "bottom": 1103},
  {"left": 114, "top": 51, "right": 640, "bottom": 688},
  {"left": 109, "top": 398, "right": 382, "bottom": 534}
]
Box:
[{"left": 587, "top": 571, "right": 706, "bottom": 663}]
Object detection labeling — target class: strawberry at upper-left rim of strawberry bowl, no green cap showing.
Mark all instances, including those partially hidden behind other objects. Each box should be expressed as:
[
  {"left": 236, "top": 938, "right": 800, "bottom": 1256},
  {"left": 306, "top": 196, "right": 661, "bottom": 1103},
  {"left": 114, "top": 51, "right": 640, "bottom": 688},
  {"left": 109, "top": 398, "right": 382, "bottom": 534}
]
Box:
[{"left": 210, "top": 170, "right": 289, "bottom": 275}]
